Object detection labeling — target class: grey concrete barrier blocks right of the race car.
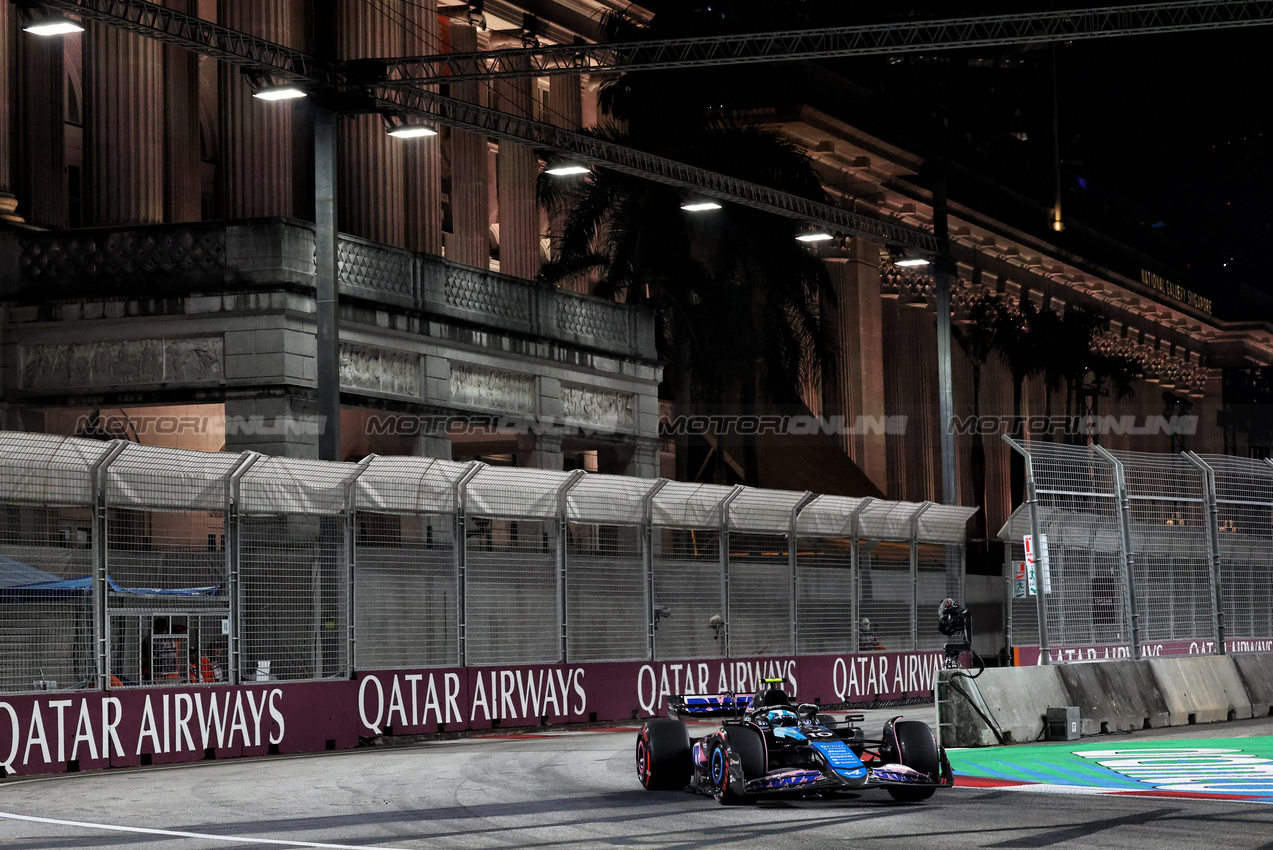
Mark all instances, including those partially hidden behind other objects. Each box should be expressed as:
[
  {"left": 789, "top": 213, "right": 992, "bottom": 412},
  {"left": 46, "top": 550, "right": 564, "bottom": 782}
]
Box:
[{"left": 937, "top": 654, "right": 1273, "bottom": 747}]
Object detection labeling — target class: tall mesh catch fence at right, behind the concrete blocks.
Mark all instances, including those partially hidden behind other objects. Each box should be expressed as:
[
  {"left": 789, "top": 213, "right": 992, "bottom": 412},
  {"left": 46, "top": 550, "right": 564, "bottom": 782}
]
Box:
[{"left": 999, "top": 440, "right": 1273, "bottom": 663}]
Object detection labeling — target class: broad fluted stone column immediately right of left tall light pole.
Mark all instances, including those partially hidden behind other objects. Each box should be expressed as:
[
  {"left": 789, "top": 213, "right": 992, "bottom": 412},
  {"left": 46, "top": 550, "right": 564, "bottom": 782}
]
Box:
[{"left": 336, "top": 0, "right": 404, "bottom": 247}]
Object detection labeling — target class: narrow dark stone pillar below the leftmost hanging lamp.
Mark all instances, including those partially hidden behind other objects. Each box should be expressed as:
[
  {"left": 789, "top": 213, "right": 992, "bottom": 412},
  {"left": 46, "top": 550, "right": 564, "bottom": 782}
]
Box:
[{"left": 17, "top": 33, "right": 67, "bottom": 228}]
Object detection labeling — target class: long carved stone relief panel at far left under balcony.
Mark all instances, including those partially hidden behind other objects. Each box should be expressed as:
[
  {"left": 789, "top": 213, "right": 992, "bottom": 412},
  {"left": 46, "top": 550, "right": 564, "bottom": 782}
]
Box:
[{"left": 22, "top": 336, "right": 225, "bottom": 389}]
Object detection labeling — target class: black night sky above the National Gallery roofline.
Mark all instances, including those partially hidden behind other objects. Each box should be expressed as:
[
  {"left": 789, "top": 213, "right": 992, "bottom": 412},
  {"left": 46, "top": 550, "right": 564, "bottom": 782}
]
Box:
[{"left": 628, "top": 0, "right": 1273, "bottom": 318}]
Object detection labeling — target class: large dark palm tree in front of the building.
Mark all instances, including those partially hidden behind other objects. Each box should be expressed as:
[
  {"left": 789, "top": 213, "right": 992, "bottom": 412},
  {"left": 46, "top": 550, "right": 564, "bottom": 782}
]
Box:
[{"left": 540, "top": 17, "right": 835, "bottom": 484}]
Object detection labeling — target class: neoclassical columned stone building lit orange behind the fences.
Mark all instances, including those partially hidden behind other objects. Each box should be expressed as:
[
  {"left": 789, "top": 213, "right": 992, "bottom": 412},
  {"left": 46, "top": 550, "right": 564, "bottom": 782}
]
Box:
[{"left": 0, "top": 0, "right": 1273, "bottom": 542}]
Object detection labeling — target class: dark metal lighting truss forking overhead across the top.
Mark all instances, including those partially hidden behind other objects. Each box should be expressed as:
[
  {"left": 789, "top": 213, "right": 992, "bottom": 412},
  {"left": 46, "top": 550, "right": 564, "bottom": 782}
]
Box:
[{"left": 24, "top": 0, "right": 1273, "bottom": 254}]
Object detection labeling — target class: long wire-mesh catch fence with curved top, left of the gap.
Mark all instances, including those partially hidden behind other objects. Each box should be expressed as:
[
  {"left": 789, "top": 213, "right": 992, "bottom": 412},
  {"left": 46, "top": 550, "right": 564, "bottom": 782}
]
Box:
[{"left": 0, "top": 431, "right": 973, "bottom": 692}]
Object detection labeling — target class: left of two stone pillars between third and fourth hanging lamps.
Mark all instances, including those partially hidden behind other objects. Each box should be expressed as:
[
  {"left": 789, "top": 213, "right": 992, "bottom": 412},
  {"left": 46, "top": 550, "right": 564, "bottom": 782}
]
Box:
[{"left": 447, "top": 23, "right": 490, "bottom": 268}]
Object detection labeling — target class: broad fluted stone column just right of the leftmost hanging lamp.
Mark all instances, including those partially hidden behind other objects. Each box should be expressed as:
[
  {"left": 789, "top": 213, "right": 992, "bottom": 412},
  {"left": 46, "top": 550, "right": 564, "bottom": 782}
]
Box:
[{"left": 83, "top": 22, "right": 164, "bottom": 225}]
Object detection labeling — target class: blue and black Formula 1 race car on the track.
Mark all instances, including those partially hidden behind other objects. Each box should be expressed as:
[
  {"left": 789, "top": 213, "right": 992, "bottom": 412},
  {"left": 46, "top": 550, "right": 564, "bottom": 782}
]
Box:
[{"left": 637, "top": 679, "right": 955, "bottom": 805}]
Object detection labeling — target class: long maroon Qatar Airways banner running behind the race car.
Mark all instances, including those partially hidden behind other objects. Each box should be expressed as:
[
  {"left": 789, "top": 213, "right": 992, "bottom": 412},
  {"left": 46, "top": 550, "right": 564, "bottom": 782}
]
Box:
[{"left": 0, "top": 651, "right": 943, "bottom": 776}]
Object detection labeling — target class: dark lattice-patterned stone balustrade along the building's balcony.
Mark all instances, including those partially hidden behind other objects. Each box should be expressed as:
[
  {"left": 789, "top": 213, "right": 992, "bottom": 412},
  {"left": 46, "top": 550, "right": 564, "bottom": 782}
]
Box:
[{"left": 0, "top": 219, "right": 654, "bottom": 359}]
